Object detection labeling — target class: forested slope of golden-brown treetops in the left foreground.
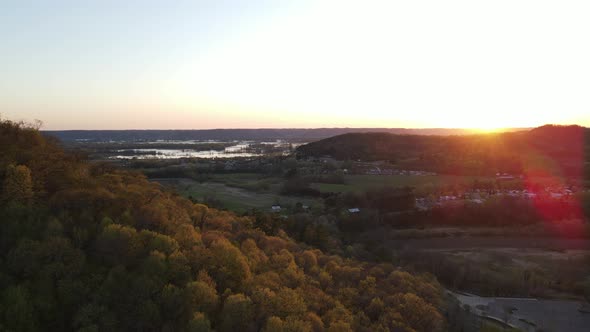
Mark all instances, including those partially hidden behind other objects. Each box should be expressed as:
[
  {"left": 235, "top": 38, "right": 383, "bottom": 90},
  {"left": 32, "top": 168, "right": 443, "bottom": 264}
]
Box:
[{"left": 0, "top": 120, "right": 447, "bottom": 332}]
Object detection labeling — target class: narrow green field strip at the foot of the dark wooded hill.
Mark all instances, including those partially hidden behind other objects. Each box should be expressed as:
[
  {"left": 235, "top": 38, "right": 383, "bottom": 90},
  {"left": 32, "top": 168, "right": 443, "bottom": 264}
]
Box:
[{"left": 312, "top": 175, "right": 494, "bottom": 192}]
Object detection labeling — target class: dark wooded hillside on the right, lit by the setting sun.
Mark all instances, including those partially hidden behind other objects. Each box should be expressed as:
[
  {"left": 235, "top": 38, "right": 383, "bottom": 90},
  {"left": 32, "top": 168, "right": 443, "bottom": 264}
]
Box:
[{"left": 297, "top": 125, "right": 590, "bottom": 179}]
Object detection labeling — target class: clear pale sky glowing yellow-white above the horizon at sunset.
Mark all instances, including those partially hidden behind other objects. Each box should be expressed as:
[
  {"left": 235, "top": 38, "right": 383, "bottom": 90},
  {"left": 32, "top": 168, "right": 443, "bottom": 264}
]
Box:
[{"left": 0, "top": 0, "right": 590, "bottom": 129}]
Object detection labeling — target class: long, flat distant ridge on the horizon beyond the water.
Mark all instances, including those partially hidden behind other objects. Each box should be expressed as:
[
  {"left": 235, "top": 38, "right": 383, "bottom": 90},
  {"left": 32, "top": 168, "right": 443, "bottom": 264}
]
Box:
[{"left": 43, "top": 128, "right": 523, "bottom": 142}]
